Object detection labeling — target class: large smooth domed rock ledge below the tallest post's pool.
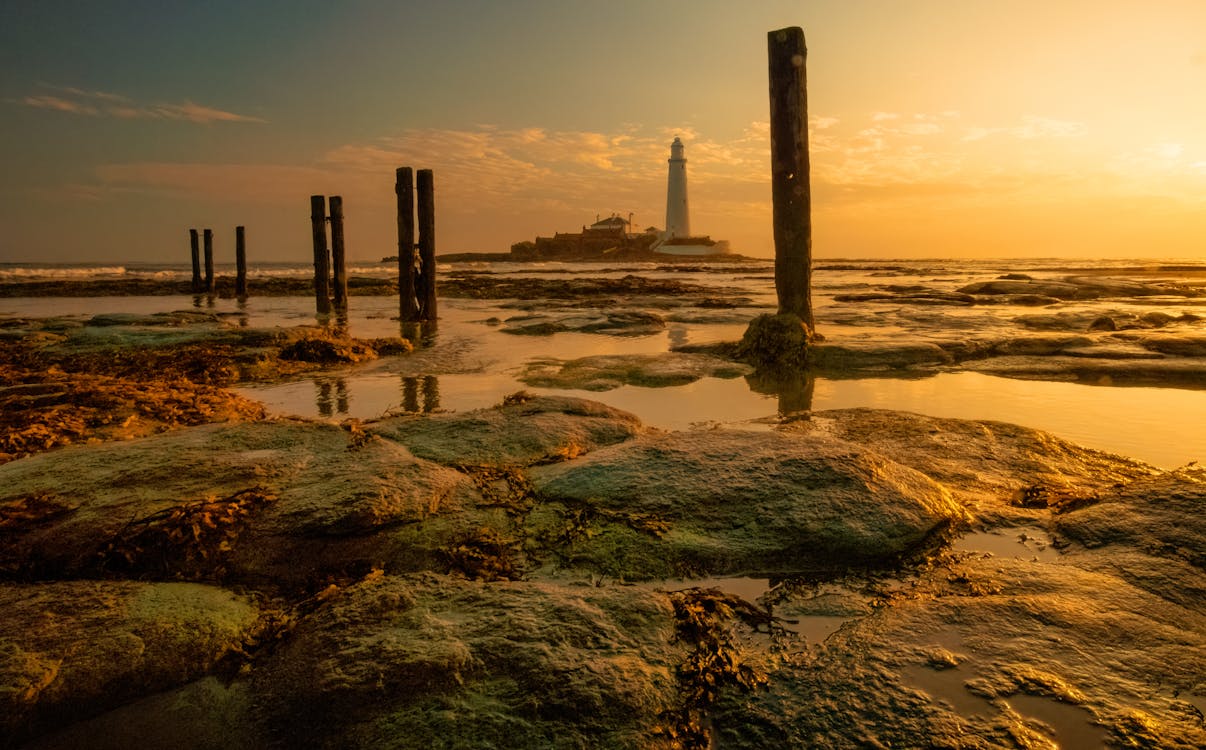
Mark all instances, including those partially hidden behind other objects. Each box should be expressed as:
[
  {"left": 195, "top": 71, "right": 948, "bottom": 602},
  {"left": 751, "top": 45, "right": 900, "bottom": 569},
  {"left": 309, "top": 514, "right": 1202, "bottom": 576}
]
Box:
[{"left": 531, "top": 429, "right": 966, "bottom": 578}]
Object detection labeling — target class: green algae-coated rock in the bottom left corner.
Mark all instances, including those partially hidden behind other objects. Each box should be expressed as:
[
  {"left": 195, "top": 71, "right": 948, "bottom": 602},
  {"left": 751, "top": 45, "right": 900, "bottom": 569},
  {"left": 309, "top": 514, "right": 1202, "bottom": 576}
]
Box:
[{"left": 0, "top": 581, "right": 259, "bottom": 737}]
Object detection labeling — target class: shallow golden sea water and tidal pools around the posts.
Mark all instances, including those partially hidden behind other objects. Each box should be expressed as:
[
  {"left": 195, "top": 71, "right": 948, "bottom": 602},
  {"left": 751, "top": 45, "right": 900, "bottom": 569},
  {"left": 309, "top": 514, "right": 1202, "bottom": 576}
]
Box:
[{"left": 0, "top": 258, "right": 1206, "bottom": 469}]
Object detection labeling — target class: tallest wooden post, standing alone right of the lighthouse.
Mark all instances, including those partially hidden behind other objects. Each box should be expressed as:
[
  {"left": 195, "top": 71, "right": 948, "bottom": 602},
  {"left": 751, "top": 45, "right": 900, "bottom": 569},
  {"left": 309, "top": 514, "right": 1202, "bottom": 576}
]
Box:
[{"left": 767, "top": 27, "right": 815, "bottom": 335}]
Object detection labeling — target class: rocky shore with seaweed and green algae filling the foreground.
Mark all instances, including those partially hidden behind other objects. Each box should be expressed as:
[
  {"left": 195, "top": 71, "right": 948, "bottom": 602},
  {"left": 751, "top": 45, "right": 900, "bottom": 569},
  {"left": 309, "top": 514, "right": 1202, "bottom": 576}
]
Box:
[{"left": 0, "top": 267, "right": 1206, "bottom": 749}]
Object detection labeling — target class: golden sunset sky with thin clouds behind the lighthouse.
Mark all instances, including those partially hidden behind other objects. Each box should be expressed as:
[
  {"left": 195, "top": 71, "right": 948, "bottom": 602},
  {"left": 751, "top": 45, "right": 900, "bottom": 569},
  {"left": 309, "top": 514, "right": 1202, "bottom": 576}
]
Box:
[{"left": 0, "top": 0, "right": 1206, "bottom": 263}]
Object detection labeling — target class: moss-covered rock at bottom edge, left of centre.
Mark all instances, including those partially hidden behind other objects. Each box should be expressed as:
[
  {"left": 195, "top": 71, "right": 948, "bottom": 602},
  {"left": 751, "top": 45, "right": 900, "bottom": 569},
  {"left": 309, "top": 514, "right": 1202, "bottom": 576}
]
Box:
[{"left": 253, "top": 574, "right": 680, "bottom": 748}]
